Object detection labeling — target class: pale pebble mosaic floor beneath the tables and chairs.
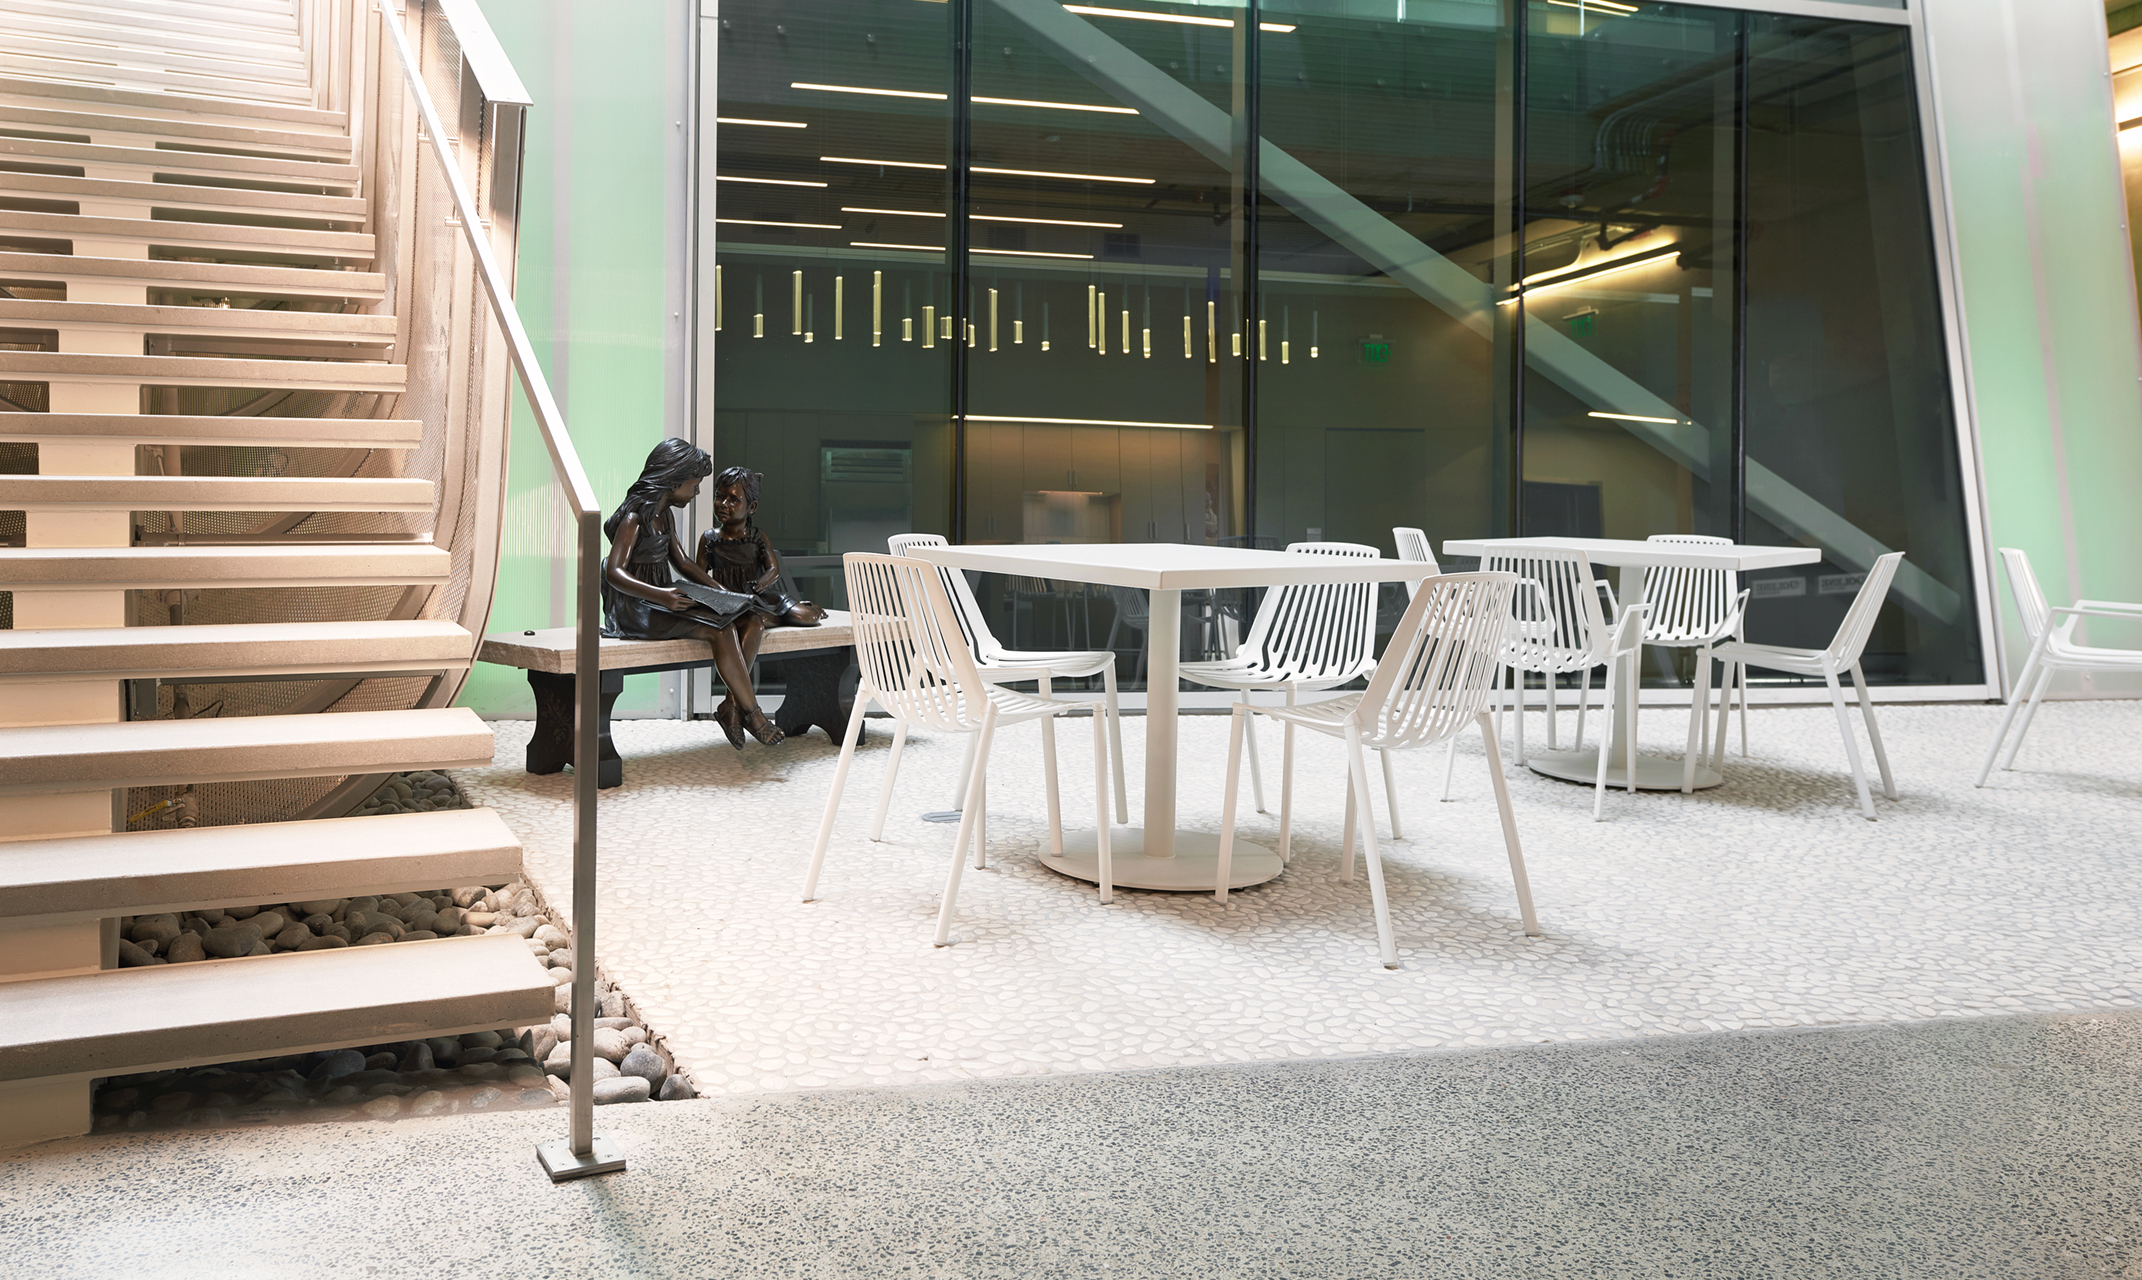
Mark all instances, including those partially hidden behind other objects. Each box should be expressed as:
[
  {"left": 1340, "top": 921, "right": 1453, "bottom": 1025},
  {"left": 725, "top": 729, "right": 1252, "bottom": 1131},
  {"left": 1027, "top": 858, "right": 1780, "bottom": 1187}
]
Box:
[{"left": 456, "top": 702, "right": 2142, "bottom": 1096}]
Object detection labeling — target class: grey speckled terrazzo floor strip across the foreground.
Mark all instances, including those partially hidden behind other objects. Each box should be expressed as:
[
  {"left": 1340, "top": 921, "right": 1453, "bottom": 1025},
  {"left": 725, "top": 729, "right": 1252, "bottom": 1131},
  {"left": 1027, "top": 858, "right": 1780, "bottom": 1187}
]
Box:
[{"left": 12, "top": 1012, "right": 2142, "bottom": 1280}]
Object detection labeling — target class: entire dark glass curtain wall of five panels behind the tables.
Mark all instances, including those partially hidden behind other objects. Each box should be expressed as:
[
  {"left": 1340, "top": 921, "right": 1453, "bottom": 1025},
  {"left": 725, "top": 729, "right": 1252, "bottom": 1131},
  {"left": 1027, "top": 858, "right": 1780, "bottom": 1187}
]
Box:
[{"left": 715, "top": 0, "right": 1981, "bottom": 687}]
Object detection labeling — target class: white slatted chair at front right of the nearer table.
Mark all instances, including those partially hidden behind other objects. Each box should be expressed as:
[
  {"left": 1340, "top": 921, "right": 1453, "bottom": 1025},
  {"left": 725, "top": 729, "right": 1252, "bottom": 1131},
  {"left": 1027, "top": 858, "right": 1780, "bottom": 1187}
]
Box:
[{"left": 1212, "top": 574, "right": 1540, "bottom": 970}]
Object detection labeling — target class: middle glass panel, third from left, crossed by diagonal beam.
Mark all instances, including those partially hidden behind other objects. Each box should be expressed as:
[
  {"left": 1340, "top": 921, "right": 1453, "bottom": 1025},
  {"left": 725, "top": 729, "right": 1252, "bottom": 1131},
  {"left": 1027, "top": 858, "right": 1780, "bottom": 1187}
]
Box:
[{"left": 1257, "top": 0, "right": 1512, "bottom": 577}]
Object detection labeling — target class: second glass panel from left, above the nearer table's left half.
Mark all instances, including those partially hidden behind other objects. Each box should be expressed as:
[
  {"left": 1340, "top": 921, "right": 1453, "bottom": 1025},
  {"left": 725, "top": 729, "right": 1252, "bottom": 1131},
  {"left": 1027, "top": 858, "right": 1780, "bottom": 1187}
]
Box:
[{"left": 964, "top": 4, "right": 1242, "bottom": 687}]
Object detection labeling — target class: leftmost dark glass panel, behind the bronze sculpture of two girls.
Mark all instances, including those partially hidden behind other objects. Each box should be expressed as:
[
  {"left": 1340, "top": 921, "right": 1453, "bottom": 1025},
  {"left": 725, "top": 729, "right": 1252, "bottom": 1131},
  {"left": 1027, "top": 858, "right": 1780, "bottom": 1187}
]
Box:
[{"left": 715, "top": 0, "right": 953, "bottom": 606}]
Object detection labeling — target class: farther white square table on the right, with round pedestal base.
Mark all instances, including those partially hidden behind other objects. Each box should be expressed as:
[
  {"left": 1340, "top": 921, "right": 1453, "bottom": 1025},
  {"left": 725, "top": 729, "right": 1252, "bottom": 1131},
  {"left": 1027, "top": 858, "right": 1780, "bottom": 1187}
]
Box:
[{"left": 1444, "top": 537, "right": 1823, "bottom": 792}]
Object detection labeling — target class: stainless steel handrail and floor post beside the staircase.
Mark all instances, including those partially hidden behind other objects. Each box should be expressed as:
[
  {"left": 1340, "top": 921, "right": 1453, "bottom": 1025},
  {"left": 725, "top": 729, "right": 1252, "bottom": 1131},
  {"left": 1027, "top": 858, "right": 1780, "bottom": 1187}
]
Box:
[{"left": 375, "top": 0, "right": 625, "bottom": 1182}]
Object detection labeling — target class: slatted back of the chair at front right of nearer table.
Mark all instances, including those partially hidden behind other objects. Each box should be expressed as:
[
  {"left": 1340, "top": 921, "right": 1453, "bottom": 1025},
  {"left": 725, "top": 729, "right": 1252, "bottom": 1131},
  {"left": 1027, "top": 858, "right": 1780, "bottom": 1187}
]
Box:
[{"left": 1358, "top": 574, "right": 1517, "bottom": 747}]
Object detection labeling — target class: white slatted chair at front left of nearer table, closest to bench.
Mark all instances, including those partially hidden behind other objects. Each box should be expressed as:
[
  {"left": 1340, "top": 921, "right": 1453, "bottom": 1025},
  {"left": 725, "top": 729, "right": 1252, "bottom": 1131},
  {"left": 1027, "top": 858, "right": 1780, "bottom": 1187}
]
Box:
[{"left": 803, "top": 552, "right": 1114, "bottom": 946}]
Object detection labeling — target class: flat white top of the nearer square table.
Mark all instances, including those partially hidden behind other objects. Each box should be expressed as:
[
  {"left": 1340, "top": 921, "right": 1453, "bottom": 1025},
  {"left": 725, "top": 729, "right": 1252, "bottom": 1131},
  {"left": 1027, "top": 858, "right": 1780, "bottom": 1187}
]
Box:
[{"left": 906, "top": 542, "right": 1435, "bottom": 591}]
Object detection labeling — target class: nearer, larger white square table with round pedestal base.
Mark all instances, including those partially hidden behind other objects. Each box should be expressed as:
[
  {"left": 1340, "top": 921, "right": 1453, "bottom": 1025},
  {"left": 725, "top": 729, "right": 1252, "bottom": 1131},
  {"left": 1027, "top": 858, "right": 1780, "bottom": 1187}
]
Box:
[{"left": 908, "top": 542, "right": 1439, "bottom": 890}]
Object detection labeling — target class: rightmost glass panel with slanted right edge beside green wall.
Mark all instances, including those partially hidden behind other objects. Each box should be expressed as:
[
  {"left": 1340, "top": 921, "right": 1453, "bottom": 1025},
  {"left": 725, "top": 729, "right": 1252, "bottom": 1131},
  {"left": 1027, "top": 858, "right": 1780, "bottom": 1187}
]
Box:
[{"left": 1746, "top": 17, "right": 1983, "bottom": 685}]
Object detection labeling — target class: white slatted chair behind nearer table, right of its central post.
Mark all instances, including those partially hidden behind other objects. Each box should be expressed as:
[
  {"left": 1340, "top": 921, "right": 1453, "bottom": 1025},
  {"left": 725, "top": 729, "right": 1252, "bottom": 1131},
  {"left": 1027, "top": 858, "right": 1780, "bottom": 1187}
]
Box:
[{"left": 1178, "top": 542, "right": 1405, "bottom": 839}]
